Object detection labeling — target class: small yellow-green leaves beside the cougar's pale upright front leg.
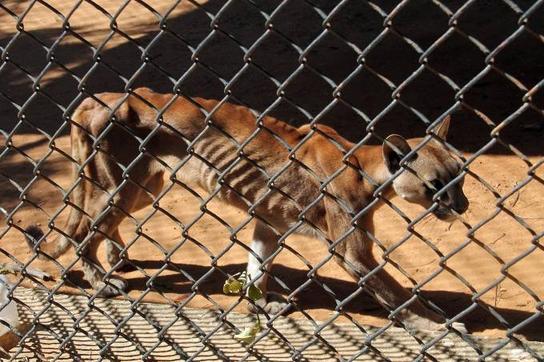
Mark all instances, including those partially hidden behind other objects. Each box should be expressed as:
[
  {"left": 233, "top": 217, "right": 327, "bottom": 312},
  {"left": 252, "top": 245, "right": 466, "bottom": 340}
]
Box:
[{"left": 223, "top": 271, "right": 263, "bottom": 343}]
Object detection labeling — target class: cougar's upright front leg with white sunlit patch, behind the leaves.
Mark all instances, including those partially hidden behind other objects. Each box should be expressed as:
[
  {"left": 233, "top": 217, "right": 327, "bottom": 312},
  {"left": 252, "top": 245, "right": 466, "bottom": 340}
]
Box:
[{"left": 247, "top": 221, "right": 287, "bottom": 314}]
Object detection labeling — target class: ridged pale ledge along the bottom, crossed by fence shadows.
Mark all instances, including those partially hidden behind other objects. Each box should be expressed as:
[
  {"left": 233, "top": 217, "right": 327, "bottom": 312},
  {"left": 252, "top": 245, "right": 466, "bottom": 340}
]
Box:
[{"left": 5, "top": 288, "right": 544, "bottom": 361}]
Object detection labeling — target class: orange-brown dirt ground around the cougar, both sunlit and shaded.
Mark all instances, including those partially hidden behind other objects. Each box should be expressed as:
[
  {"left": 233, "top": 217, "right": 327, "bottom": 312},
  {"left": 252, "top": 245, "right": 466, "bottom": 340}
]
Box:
[{"left": 0, "top": 0, "right": 544, "bottom": 339}]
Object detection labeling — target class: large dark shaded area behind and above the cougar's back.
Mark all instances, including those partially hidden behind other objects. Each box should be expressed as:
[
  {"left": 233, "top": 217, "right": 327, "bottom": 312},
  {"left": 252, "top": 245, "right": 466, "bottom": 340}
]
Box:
[{"left": 0, "top": 0, "right": 544, "bottom": 155}]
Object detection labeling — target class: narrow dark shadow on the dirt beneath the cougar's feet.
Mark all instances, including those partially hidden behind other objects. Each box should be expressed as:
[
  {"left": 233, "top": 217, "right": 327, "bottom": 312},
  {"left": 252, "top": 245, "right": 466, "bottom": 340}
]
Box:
[{"left": 67, "top": 260, "right": 544, "bottom": 341}]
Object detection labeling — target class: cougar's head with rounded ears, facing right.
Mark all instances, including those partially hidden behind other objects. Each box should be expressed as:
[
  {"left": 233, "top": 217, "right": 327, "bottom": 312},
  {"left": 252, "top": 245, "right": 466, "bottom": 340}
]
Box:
[{"left": 383, "top": 116, "right": 468, "bottom": 221}]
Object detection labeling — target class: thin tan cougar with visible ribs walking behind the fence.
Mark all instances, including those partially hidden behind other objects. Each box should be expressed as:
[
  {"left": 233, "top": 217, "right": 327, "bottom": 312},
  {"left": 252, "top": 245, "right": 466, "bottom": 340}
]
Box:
[{"left": 25, "top": 88, "right": 467, "bottom": 328}]
